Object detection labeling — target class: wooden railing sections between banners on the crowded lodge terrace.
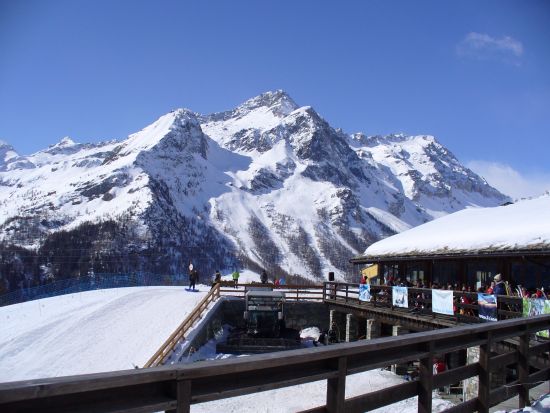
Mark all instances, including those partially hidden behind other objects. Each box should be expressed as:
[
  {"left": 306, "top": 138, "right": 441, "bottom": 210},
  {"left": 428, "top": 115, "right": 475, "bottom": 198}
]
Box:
[{"left": 323, "top": 282, "right": 523, "bottom": 323}]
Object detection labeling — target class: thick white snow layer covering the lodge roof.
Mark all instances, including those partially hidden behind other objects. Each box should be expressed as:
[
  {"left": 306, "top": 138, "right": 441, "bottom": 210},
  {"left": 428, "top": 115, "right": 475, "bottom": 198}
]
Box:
[{"left": 354, "top": 195, "right": 550, "bottom": 261}]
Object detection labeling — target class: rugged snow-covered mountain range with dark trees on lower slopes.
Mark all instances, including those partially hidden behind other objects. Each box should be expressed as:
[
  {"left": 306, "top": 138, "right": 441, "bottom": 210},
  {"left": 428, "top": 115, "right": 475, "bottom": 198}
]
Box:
[{"left": 0, "top": 91, "right": 508, "bottom": 288}]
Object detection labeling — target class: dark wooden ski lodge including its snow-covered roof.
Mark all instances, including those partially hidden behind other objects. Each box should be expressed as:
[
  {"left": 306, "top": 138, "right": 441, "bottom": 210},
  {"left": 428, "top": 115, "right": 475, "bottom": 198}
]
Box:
[{"left": 351, "top": 195, "right": 550, "bottom": 291}]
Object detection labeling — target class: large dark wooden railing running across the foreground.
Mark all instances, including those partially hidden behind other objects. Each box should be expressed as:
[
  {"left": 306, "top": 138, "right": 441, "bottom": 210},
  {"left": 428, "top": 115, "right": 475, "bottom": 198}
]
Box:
[{"left": 0, "top": 315, "right": 550, "bottom": 413}]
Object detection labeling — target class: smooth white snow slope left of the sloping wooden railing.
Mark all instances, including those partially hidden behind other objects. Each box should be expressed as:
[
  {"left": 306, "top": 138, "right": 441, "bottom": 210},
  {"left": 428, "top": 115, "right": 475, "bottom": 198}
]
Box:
[{"left": 0, "top": 286, "right": 210, "bottom": 382}]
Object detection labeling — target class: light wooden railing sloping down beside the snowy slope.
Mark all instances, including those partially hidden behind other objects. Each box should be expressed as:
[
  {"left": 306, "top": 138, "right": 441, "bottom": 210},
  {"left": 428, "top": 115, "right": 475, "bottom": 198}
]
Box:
[{"left": 143, "top": 284, "right": 220, "bottom": 367}]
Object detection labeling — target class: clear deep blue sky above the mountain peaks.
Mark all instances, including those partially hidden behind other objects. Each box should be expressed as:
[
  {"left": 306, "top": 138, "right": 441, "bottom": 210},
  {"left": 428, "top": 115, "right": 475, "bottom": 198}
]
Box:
[{"left": 0, "top": 0, "right": 550, "bottom": 196}]
